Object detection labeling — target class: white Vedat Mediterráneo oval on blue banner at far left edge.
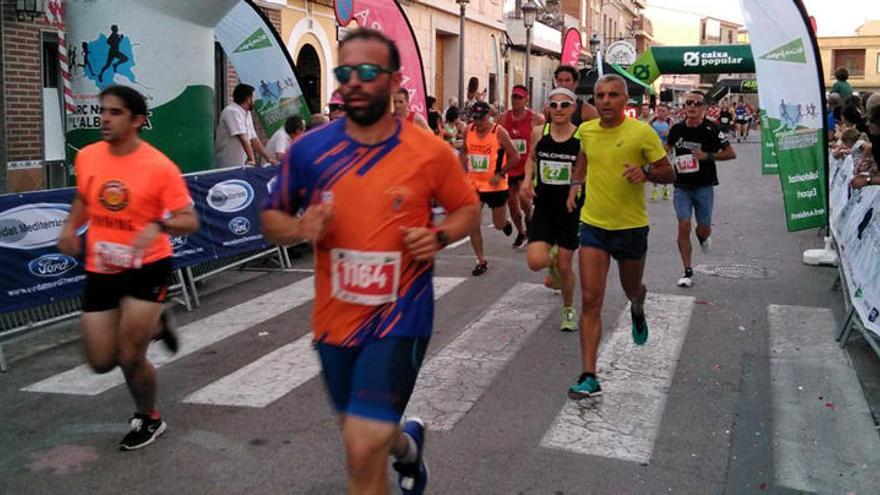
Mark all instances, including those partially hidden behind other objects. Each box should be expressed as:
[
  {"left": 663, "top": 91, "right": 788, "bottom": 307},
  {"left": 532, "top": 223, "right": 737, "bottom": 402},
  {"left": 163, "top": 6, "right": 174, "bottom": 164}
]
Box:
[{"left": 0, "top": 203, "right": 70, "bottom": 250}]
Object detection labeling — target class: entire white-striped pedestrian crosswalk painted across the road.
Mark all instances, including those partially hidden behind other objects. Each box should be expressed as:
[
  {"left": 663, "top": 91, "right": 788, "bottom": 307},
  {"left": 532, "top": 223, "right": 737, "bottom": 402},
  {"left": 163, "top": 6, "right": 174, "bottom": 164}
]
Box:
[{"left": 22, "top": 277, "right": 880, "bottom": 492}]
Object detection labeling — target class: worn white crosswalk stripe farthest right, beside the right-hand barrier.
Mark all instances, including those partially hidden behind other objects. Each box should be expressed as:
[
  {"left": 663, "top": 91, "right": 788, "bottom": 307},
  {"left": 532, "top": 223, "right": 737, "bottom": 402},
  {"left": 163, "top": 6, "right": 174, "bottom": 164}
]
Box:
[{"left": 767, "top": 305, "right": 880, "bottom": 493}]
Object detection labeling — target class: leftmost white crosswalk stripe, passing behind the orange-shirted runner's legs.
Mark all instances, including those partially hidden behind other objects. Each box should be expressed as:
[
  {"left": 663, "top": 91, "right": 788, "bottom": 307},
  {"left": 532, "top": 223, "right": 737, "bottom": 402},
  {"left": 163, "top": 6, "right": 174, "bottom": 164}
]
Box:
[{"left": 22, "top": 277, "right": 314, "bottom": 395}]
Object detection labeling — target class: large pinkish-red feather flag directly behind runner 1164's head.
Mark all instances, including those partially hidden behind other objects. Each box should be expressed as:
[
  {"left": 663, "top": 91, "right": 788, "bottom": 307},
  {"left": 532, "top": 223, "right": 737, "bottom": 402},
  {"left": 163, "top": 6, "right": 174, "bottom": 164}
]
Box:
[{"left": 354, "top": 0, "right": 428, "bottom": 121}]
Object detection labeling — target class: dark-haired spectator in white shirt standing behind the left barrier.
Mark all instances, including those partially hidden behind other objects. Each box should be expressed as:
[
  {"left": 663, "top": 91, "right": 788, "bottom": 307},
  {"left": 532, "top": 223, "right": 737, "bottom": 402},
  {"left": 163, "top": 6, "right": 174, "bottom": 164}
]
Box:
[{"left": 214, "top": 84, "right": 274, "bottom": 168}]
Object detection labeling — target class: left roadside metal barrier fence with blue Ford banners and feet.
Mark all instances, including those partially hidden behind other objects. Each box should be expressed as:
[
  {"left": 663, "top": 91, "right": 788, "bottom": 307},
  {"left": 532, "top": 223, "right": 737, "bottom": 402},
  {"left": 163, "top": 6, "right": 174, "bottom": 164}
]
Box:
[{"left": 0, "top": 167, "right": 292, "bottom": 370}]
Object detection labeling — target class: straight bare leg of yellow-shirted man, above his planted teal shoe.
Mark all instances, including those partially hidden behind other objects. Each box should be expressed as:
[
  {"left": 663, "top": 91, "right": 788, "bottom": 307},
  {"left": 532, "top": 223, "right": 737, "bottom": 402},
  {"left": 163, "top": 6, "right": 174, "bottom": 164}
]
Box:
[{"left": 578, "top": 246, "right": 611, "bottom": 373}]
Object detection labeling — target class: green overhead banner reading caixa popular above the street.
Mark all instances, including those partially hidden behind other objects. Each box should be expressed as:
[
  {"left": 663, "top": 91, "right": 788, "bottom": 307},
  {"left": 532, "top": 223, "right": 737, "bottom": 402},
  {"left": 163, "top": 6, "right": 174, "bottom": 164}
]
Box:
[{"left": 627, "top": 45, "right": 755, "bottom": 84}]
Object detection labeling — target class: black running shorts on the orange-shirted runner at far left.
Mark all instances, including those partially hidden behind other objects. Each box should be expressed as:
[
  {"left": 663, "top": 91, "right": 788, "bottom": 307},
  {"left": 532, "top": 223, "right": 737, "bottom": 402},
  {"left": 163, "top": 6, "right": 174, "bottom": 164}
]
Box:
[{"left": 83, "top": 258, "right": 172, "bottom": 313}]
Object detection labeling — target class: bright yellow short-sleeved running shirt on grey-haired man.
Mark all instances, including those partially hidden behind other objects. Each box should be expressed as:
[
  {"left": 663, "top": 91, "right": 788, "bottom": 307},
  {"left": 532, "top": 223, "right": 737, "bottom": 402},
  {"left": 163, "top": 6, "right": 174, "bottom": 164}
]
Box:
[{"left": 575, "top": 117, "right": 666, "bottom": 230}]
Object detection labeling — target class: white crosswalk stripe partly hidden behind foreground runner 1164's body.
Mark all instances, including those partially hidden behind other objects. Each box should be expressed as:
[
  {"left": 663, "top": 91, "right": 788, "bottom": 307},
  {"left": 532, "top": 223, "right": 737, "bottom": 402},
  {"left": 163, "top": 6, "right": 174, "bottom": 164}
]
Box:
[{"left": 183, "top": 277, "right": 465, "bottom": 407}]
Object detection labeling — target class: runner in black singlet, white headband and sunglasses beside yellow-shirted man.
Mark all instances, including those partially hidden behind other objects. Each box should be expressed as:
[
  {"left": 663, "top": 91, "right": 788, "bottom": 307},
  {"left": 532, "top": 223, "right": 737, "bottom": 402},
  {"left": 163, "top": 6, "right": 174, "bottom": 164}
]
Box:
[{"left": 522, "top": 88, "right": 581, "bottom": 332}]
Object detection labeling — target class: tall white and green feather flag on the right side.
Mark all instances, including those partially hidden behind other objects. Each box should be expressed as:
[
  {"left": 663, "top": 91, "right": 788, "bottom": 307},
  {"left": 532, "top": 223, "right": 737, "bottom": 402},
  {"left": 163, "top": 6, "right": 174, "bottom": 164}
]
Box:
[{"left": 741, "top": 0, "right": 828, "bottom": 231}]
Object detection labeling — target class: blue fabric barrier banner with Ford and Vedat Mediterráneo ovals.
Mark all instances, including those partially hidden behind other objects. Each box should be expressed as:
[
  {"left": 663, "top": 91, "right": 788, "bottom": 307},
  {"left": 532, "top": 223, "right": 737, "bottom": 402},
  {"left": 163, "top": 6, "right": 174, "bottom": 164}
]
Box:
[{"left": 0, "top": 167, "right": 276, "bottom": 313}]
